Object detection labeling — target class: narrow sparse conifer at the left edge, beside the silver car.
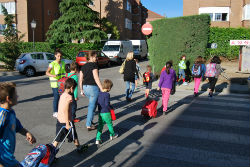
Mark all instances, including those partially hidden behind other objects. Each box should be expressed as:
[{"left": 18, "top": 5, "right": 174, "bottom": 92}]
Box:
[{"left": 0, "top": 6, "right": 24, "bottom": 70}]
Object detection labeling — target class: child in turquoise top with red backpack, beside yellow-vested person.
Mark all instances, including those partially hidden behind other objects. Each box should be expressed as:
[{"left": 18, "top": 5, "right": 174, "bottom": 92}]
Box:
[{"left": 67, "top": 62, "right": 80, "bottom": 123}]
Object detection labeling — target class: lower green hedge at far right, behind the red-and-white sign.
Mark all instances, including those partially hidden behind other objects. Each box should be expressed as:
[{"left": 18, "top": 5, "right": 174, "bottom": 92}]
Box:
[{"left": 207, "top": 27, "right": 250, "bottom": 59}]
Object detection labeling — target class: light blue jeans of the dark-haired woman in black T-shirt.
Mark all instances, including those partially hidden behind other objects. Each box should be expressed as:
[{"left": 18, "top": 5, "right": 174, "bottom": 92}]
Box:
[{"left": 83, "top": 85, "right": 99, "bottom": 127}]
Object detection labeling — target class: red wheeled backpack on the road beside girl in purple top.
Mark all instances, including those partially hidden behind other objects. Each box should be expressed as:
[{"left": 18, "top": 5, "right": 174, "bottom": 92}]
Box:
[{"left": 141, "top": 100, "right": 158, "bottom": 118}]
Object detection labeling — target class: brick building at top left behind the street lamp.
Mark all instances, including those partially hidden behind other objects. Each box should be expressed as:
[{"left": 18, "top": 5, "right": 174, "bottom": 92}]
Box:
[{"left": 0, "top": 0, "right": 59, "bottom": 42}]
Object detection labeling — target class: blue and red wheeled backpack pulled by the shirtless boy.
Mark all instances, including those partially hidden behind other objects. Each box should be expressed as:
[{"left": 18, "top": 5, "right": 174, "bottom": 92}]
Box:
[{"left": 21, "top": 144, "right": 57, "bottom": 167}]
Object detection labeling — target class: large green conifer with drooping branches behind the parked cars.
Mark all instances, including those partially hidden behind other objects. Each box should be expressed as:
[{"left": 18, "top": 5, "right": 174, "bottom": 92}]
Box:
[{"left": 47, "top": 0, "right": 107, "bottom": 43}]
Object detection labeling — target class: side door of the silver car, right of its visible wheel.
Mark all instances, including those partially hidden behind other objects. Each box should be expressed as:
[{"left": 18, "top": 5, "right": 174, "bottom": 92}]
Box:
[{"left": 30, "top": 53, "right": 46, "bottom": 72}]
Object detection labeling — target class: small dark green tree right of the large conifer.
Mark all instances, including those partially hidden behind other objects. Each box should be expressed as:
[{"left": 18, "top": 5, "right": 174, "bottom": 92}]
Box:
[{"left": 101, "top": 18, "right": 120, "bottom": 39}]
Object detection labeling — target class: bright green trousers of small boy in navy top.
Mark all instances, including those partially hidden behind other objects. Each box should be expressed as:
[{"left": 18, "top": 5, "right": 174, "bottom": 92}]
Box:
[{"left": 96, "top": 112, "right": 115, "bottom": 140}]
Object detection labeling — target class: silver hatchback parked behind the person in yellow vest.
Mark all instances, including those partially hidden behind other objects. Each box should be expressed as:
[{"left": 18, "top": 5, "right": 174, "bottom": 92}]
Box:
[{"left": 15, "top": 52, "right": 72, "bottom": 77}]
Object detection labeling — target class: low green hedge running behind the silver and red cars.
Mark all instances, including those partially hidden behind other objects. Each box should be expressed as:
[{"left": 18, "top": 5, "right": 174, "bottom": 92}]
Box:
[{"left": 20, "top": 42, "right": 101, "bottom": 60}]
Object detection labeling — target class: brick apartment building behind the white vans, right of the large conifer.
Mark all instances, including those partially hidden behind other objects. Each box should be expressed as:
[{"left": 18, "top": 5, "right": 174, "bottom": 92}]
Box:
[{"left": 90, "top": 0, "right": 147, "bottom": 40}]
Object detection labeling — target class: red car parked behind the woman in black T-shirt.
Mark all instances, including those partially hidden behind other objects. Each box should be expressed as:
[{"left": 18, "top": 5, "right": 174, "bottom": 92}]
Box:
[{"left": 76, "top": 50, "right": 111, "bottom": 67}]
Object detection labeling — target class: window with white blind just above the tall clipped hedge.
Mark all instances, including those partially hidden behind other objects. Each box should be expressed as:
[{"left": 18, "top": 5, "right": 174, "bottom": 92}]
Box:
[{"left": 199, "top": 7, "right": 230, "bottom": 21}]
